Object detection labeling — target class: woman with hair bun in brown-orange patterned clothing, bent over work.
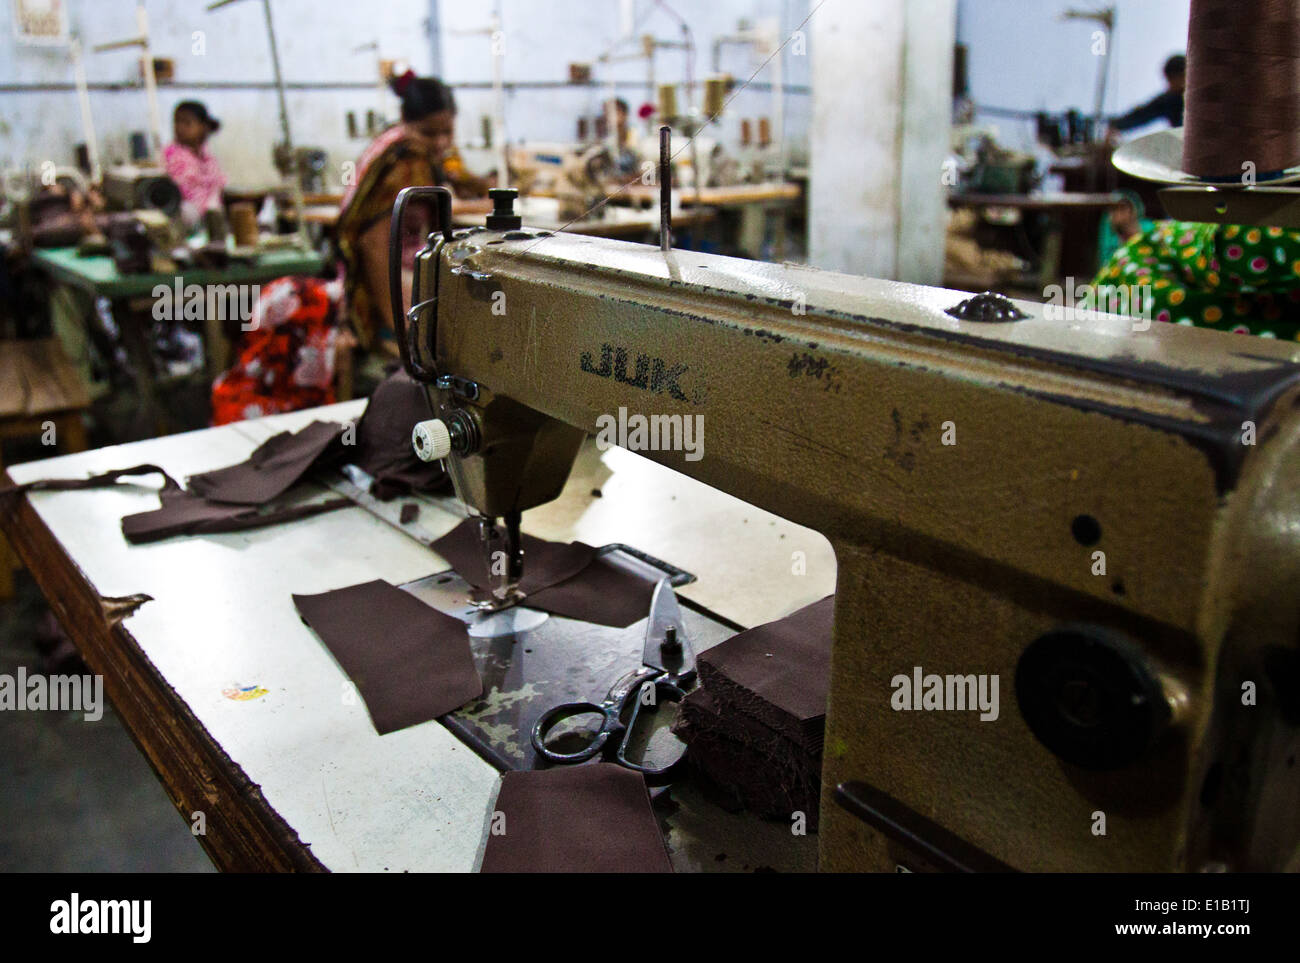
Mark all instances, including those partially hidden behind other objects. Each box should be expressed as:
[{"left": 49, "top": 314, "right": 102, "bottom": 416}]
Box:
[{"left": 337, "top": 71, "right": 489, "bottom": 356}]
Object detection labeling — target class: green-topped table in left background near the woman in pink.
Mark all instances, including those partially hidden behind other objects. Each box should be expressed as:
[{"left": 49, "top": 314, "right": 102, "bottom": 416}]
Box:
[{"left": 31, "top": 247, "right": 325, "bottom": 430}]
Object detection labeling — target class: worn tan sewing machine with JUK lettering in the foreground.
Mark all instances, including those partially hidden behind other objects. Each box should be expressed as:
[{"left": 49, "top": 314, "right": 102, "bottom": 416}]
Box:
[{"left": 394, "top": 188, "right": 1300, "bottom": 872}]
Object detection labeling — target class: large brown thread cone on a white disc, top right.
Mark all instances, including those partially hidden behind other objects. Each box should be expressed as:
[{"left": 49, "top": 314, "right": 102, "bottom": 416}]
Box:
[{"left": 1183, "top": 0, "right": 1300, "bottom": 181}]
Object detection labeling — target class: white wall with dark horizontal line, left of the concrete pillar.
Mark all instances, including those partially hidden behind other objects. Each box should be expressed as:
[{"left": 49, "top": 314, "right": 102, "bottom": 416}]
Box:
[{"left": 0, "top": 0, "right": 810, "bottom": 187}]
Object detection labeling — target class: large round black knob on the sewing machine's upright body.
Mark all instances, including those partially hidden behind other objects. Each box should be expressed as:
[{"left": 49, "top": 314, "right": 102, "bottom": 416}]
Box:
[{"left": 1015, "top": 625, "right": 1173, "bottom": 769}]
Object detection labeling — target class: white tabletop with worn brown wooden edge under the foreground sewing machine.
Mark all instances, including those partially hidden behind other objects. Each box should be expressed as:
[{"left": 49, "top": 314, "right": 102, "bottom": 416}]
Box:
[{"left": 0, "top": 402, "right": 835, "bottom": 872}]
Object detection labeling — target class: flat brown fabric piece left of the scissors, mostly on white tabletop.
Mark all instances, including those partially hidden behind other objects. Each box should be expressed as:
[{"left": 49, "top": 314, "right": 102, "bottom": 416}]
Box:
[{"left": 294, "top": 580, "right": 484, "bottom": 736}]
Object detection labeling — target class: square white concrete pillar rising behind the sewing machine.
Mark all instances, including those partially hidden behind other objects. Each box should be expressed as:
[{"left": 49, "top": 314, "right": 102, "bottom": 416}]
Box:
[{"left": 807, "top": 0, "right": 957, "bottom": 285}]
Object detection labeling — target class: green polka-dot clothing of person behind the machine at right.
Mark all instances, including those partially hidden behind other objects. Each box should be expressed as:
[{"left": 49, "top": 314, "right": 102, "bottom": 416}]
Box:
[{"left": 1093, "top": 221, "right": 1300, "bottom": 340}]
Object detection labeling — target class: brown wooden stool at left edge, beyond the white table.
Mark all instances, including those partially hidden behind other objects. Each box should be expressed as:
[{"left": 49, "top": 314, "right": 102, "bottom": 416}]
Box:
[{"left": 0, "top": 339, "right": 90, "bottom": 599}]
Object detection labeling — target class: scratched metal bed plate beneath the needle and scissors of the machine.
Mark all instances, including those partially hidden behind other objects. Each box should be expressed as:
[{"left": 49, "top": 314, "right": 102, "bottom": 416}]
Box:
[{"left": 400, "top": 558, "right": 816, "bottom": 872}]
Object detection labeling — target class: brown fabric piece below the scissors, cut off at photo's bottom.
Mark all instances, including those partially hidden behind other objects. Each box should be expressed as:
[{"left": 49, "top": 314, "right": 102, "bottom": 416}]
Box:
[{"left": 481, "top": 763, "right": 672, "bottom": 873}]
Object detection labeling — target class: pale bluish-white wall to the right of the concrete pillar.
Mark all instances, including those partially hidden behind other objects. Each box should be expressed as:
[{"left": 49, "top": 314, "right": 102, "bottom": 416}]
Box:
[{"left": 957, "top": 0, "right": 1191, "bottom": 149}]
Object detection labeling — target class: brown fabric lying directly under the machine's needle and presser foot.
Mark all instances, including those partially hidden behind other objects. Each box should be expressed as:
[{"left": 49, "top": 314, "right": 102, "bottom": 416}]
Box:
[{"left": 433, "top": 520, "right": 655, "bottom": 629}]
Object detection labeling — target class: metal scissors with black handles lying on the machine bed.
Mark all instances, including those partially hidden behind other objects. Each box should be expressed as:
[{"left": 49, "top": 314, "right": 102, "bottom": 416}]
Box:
[{"left": 533, "top": 578, "right": 696, "bottom": 776}]
